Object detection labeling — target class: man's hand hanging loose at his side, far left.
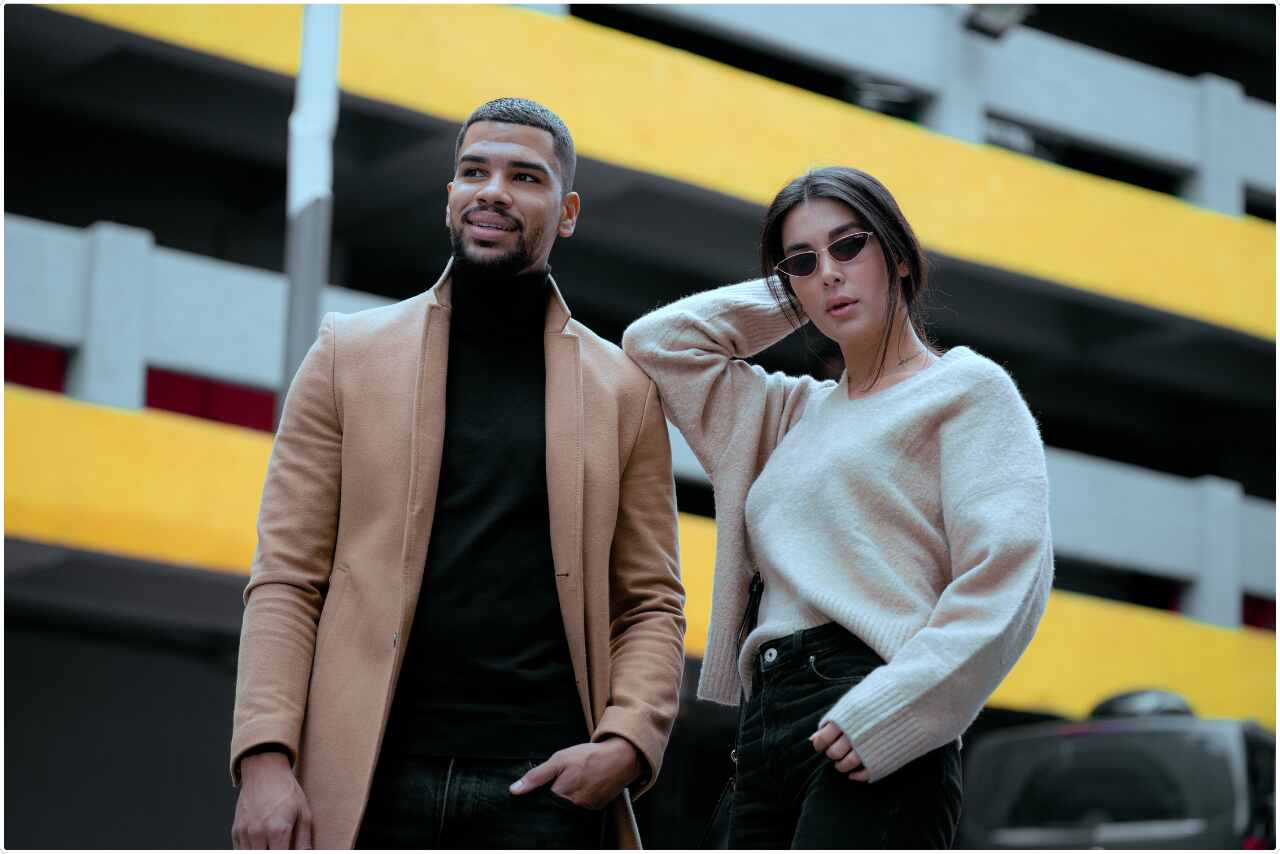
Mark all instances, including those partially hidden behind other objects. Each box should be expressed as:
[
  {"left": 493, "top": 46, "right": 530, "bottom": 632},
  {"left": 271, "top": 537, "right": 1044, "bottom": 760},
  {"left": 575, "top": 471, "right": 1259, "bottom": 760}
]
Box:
[{"left": 232, "top": 750, "right": 311, "bottom": 849}]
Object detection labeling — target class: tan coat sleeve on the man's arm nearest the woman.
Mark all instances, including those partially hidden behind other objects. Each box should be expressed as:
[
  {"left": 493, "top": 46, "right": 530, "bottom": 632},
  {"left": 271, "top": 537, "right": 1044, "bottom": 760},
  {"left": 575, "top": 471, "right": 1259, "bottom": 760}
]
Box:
[{"left": 591, "top": 383, "right": 685, "bottom": 795}]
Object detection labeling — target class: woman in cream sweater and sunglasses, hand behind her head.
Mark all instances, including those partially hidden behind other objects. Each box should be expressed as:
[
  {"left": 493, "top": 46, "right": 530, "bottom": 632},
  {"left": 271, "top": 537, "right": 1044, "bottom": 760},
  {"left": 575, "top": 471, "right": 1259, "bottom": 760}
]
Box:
[{"left": 623, "top": 168, "right": 1052, "bottom": 848}]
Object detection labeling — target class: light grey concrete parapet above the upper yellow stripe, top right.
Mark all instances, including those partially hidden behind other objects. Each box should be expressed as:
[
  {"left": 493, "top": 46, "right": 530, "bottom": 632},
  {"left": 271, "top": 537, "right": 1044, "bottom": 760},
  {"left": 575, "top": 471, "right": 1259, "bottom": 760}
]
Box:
[{"left": 631, "top": 4, "right": 1276, "bottom": 215}]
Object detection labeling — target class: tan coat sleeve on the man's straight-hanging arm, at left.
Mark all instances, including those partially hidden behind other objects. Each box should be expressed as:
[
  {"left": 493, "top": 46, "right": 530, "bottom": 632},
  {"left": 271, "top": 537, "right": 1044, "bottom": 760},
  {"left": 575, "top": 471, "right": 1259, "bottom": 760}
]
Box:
[{"left": 230, "top": 314, "right": 342, "bottom": 785}]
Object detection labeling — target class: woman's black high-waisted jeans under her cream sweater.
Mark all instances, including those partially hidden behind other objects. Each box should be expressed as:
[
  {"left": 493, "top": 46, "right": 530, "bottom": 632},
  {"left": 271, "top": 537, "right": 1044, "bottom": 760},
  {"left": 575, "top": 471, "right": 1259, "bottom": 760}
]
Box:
[{"left": 730, "top": 624, "right": 961, "bottom": 849}]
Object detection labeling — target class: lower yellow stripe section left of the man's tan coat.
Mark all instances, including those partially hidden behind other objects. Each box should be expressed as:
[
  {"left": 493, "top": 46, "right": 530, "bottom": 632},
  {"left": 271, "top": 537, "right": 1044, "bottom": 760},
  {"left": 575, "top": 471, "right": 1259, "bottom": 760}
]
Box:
[{"left": 4, "top": 384, "right": 271, "bottom": 572}]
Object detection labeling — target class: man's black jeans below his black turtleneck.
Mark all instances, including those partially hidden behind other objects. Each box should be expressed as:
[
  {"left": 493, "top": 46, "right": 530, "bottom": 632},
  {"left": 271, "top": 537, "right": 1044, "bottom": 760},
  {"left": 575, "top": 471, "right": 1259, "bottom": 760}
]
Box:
[{"left": 356, "top": 757, "right": 604, "bottom": 849}]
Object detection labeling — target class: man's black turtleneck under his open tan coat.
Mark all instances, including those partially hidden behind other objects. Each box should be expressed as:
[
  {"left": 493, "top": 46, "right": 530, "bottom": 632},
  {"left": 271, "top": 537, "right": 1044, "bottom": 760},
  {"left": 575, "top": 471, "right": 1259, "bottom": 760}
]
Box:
[{"left": 383, "top": 261, "right": 588, "bottom": 759}]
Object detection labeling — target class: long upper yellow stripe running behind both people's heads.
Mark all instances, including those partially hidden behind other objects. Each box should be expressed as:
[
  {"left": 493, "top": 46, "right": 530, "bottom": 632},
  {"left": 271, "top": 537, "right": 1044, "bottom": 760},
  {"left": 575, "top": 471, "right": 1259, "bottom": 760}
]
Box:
[{"left": 58, "top": 5, "right": 1276, "bottom": 339}]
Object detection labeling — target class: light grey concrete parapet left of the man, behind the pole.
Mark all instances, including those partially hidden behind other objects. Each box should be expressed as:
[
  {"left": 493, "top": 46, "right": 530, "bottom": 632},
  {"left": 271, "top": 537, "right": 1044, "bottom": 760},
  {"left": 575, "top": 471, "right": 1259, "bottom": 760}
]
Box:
[{"left": 4, "top": 214, "right": 389, "bottom": 391}]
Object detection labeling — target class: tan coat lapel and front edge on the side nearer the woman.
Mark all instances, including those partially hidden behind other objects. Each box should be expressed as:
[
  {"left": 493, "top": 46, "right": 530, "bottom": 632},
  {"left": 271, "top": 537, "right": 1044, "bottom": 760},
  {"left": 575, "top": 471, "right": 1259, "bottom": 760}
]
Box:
[{"left": 543, "top": 279, "right": 595, "bottom": 729}]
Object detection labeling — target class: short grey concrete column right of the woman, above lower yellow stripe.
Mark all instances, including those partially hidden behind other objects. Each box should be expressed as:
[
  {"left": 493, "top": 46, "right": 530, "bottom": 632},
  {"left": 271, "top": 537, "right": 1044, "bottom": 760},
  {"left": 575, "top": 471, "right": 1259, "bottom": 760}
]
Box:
[{"left": 1183, "top": 476, "right": 1244, "bottom": 629}]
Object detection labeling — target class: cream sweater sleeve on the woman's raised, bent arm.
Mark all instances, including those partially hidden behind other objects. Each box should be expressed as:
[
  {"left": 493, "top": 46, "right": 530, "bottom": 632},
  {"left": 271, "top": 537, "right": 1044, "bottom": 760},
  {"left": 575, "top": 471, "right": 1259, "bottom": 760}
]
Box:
[{"left": 622, "top": 279, "right": 831, "bottom": 481}]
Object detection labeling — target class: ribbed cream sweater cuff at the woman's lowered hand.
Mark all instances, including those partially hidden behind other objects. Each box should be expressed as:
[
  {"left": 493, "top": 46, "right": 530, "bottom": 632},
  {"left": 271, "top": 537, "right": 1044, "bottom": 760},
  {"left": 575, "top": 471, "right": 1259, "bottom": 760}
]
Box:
[{"left": 818, "top": 677, "right": 933, "bottom": 781}]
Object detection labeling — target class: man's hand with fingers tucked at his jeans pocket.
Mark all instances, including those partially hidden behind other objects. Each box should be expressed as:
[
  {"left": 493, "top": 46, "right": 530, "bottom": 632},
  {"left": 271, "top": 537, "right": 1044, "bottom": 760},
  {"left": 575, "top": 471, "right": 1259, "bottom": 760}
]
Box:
[{"left": 511, "top": 736, "right": 640, "bottom": 809}]
